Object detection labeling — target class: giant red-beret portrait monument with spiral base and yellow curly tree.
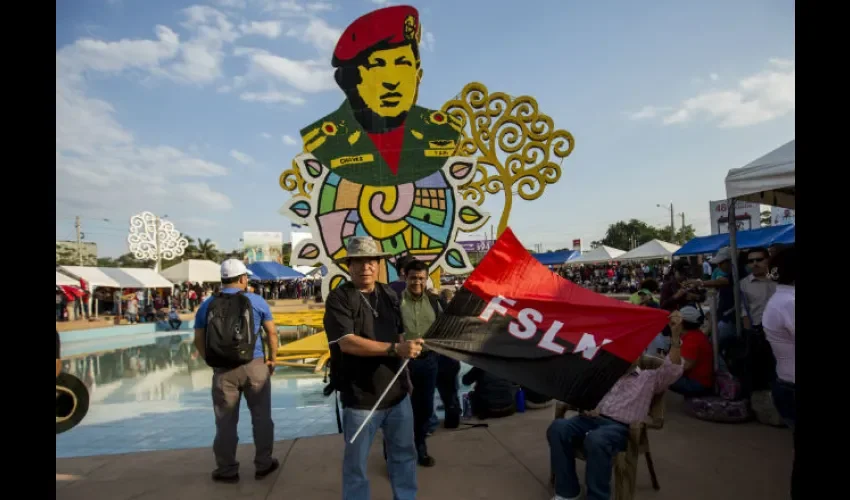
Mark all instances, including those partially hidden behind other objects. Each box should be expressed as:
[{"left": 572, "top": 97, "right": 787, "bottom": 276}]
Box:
[{"left": 280, "top": 6, "right": 573, "bottom": 296}]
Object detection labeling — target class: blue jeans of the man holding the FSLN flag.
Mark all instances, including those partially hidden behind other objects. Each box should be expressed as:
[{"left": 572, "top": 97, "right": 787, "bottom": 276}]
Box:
[{"left": 342, "top": 397, "right": 416, "bottom": 500}]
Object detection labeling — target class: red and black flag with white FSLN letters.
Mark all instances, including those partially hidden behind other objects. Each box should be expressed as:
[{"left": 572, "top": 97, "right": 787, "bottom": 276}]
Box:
[{"left": 424, "top": 228, "right": 668, "bottom": 409}]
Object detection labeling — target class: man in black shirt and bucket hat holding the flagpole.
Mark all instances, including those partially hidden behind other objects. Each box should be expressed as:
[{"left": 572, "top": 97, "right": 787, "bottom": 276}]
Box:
[{"left": 324, "top": 236, "right": 422, "bottom": 500}]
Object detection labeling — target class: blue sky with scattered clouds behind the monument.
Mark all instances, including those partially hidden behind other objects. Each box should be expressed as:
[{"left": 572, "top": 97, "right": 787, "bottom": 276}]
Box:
[{"left": 56, "top": 0, "right": 795, "bottom": 256}]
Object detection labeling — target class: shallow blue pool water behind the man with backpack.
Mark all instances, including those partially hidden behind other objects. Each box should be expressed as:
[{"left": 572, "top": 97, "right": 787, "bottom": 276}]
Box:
[{"left": 56, "top": 331, "right": 468, "bottom": 458}]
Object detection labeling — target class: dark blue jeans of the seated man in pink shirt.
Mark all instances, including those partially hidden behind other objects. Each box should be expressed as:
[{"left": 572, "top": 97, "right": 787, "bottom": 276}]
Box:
[{"left": 546, "top": 415, "right": 629, "bottom": 500}]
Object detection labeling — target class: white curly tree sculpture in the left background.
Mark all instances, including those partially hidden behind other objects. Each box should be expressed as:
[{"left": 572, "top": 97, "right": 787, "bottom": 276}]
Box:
[{"left": 127, "top": 212, "right": 189, "bottom": 272}]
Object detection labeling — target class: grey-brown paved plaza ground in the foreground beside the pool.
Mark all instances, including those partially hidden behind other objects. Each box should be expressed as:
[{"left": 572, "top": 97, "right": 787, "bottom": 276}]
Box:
[{"left": 56, "top": 395, "right": 792, "bottom": 500}]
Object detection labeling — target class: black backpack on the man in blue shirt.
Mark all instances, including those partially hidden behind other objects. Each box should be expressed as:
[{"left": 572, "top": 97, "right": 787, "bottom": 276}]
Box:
[{"left": 205, "top": 291, "right": 257, "bottom": 368}]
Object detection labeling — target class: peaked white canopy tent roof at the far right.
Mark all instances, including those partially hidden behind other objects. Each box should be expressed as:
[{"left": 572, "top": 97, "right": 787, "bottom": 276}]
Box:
[{"left": 726, "top": 139, "right": 796, "bottom": 209}]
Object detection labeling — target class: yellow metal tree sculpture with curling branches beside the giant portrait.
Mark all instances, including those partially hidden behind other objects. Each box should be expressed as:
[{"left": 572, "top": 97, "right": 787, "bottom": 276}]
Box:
[{"left": 443, "top": 82, "right": 575, "bottom": 235}]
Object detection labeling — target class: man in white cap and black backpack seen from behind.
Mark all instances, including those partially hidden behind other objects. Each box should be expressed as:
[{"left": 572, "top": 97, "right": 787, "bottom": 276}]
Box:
[{"left": 195, "top": 259, "right": 280, "bottom": 483}]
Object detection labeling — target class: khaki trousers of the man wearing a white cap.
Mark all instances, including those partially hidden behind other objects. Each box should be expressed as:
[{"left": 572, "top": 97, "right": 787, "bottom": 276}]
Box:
[{"left": 212, "top": 358, "right": 274, "bottom": 476}]
